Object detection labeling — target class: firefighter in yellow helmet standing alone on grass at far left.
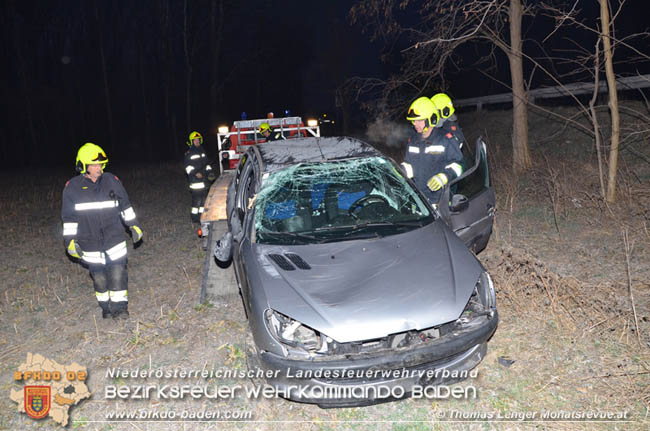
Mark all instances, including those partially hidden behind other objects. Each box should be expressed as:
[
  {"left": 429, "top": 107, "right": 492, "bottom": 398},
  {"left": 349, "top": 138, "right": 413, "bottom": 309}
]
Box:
[{"left": 61, "top": 142, "right": 143, "bottom": 319}]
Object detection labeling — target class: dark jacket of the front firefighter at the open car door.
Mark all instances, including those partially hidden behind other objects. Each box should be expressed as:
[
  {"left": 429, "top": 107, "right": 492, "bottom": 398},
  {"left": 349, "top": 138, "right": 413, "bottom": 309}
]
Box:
[{"left": 404, "top": 128, "right": 463, "bottom": 203}]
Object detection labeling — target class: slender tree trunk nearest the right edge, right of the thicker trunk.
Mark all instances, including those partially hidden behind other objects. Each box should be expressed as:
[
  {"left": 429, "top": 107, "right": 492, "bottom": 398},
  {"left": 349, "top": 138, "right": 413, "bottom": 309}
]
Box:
[{"left": 600, "top": 0, "right": 621, "bottom": 202}]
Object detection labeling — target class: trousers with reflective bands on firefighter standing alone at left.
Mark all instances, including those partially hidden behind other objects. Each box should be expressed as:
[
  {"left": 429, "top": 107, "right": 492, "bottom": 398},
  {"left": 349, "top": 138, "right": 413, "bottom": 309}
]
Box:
[{"left": 89, "top": 259, "right": 129, "bottom": 314}]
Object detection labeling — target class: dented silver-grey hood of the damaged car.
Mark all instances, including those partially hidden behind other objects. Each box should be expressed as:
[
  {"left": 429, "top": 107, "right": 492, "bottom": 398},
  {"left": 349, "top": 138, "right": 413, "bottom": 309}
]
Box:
[{"left": 249, "top": 220, "right": 483, "bottom": 342}]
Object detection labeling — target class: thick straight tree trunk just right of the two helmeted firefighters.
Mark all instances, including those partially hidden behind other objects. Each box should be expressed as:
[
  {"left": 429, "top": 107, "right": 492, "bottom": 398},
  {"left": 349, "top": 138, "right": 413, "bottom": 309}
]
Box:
[{"left": 508, "top": 0, "right": 532, "bottom": 173}]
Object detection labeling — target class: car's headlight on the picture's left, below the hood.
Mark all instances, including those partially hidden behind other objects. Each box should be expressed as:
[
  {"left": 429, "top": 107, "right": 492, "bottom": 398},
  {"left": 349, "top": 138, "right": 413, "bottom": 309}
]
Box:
[{"left": 264, "top": 309, "right": 328, "bottom": 355}]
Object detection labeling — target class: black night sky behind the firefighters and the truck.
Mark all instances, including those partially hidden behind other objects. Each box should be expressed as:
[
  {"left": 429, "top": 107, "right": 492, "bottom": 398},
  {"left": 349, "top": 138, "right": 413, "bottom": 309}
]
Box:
[{"left": 0, "top": 0, "right": 647, "bottom": 168}]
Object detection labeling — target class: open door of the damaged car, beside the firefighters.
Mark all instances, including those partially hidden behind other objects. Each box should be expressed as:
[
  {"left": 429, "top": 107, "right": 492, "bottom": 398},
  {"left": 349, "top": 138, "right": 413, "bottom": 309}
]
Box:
[{"left": 438, "top": 137, "right": 496, "bottom": 254}]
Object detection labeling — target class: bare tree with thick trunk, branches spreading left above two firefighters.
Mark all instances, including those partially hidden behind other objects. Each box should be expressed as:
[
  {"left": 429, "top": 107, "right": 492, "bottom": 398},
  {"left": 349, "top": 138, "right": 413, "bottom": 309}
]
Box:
[{"left": 351, "top": 0, "right": 538, "bottom": 172}]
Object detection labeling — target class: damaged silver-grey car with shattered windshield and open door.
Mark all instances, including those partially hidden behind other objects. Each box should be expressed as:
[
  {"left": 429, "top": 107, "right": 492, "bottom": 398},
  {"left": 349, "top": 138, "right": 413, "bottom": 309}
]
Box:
[{"left": 211, "top": 137, "right": 498, "bottom": 407}]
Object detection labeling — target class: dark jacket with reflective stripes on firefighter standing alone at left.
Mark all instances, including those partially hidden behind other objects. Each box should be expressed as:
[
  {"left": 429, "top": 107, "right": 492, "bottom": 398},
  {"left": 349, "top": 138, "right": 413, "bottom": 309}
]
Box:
[{"left": 61, "top": 172, "right": 138, "bottom": 265}]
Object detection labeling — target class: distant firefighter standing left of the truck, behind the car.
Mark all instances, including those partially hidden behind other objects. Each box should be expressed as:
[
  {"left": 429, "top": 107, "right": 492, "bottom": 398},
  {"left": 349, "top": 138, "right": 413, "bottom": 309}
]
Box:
[{"left": 184, "top": 131, "right": 213, "bottom": 223}]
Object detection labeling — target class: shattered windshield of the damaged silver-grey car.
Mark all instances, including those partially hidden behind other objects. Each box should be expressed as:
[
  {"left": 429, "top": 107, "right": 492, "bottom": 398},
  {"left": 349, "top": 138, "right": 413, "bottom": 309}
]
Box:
[{"left": 255, "top": 157, "right": 433, "bottom": 244}]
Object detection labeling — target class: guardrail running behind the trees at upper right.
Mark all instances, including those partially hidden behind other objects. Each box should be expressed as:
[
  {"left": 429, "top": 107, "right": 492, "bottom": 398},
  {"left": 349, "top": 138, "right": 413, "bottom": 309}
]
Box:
[{"left": 454, "top": 75, "right": 650, "bottom": 111}]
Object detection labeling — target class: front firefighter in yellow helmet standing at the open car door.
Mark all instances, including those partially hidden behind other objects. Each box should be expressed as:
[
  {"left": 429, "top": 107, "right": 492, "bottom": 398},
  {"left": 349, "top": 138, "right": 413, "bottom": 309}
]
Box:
[{"left": 402, "top": 97, "right": 463, "bottom": 204}]
